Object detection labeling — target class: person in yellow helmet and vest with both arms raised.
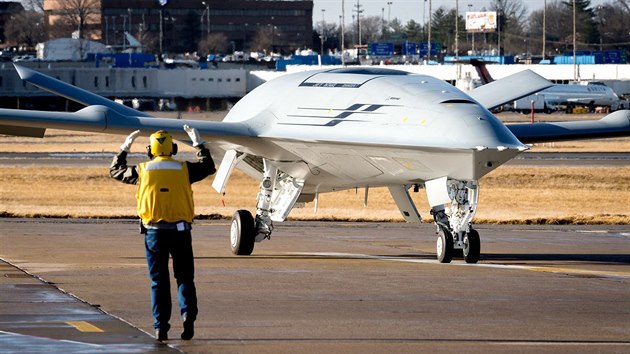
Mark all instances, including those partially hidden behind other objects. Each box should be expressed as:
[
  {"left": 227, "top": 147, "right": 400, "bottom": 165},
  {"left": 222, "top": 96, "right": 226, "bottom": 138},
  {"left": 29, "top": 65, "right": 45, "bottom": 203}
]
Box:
[{"left": 109, "top": 125, "right": 216, "bottom": 341}]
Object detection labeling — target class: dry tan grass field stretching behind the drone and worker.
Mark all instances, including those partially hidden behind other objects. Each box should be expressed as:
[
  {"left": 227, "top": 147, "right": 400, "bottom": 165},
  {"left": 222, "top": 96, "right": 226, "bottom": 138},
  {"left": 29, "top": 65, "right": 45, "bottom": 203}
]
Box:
[{"left": 0, "top": 115, "right": 630, "bottom": 224}]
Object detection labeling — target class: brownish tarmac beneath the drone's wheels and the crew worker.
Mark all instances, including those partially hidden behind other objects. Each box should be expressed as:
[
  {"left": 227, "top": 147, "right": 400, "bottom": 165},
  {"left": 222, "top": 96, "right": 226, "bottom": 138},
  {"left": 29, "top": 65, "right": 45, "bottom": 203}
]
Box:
[{"left": 0, "top": 218, "right": 630, "bottom": 353}]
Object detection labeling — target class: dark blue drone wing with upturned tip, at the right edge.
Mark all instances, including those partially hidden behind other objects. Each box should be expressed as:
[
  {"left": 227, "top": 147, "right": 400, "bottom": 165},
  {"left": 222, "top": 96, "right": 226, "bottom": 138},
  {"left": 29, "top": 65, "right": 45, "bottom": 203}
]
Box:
[{"left": 507, "top": 110, "right": 630, "bottom": 144}]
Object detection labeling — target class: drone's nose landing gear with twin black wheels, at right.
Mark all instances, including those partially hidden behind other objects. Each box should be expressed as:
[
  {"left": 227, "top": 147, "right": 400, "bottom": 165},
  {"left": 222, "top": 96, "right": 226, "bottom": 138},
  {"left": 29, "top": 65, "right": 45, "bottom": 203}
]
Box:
[{"left": 431, "top": 181, "right": 481, "bottom": 263}]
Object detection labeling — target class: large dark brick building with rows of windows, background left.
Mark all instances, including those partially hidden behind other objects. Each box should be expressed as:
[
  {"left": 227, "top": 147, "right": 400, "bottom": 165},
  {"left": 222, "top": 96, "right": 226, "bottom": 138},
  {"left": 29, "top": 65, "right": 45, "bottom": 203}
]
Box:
[{"left": 44, "top": 0, "right": 313, "bottom": 54}]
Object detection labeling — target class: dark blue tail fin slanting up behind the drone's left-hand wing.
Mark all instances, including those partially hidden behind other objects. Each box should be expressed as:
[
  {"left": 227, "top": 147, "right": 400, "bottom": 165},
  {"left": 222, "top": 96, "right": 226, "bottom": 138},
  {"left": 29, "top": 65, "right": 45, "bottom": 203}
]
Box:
[{"left": 13, "top": 64, "right": 151, "bottom": 117}]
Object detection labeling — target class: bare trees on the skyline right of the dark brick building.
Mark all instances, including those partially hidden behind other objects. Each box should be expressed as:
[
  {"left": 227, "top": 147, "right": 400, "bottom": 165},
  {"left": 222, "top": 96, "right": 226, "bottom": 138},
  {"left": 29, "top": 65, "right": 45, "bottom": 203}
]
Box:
[{"left": 314, "top": 0, "right": 630, "bottom": 56}]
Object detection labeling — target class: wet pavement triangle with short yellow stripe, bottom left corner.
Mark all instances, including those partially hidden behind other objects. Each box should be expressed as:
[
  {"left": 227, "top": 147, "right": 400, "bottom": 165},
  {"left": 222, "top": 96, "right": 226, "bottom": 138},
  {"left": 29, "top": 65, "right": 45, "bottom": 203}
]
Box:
[{"left": 0, "top": 261, "right": 179, "bottom": 353}]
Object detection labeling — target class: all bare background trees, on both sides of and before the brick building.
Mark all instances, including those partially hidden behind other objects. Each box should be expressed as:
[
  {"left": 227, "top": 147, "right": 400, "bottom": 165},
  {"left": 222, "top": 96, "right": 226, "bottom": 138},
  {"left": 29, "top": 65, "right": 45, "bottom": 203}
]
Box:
[{"left": 5, "top": 0, "right": 630, "bottom": 56}]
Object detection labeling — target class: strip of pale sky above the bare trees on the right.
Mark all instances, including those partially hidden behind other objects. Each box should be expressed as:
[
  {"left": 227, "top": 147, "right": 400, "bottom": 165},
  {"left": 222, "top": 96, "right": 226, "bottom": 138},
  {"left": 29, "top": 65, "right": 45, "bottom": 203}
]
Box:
[{"left": 313, "top": 0, "right": 610, "bottom": 24}]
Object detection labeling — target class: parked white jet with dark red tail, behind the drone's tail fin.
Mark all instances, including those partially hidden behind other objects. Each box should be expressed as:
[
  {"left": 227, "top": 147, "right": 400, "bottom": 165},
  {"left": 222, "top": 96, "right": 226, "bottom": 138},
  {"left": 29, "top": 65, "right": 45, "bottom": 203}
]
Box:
[{"left": 470, "top": 59, "right": 621, "bottom": 112}]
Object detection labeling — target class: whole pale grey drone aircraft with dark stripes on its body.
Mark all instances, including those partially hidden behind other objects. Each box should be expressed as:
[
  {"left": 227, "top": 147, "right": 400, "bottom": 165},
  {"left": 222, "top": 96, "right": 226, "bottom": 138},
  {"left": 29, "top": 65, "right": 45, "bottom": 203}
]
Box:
[{"left": 0, "top": 65, "right": 630, "bottom": 263}]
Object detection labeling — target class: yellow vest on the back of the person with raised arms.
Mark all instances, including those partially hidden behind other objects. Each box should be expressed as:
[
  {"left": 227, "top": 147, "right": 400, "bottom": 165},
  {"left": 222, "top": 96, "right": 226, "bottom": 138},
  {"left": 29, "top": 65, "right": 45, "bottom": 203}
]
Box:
[{"left": 136, "top": 157, "right": 195, "bottom": 224}]
